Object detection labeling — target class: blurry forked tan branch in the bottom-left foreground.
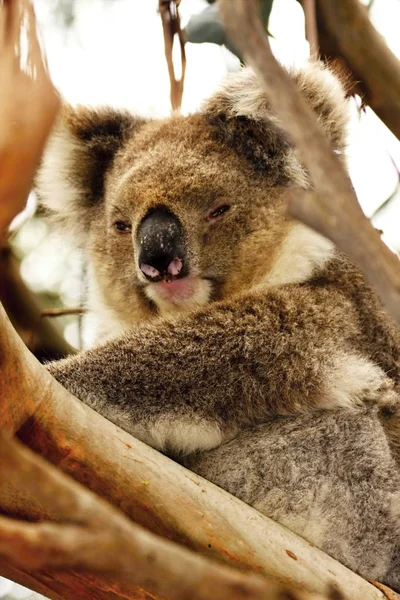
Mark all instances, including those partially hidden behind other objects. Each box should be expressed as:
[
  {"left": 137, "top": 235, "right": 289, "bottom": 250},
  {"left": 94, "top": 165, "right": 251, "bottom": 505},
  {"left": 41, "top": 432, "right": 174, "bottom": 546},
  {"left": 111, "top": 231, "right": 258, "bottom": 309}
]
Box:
[{"left": 0, "top": 434, "right": 296, "bottom": 600}]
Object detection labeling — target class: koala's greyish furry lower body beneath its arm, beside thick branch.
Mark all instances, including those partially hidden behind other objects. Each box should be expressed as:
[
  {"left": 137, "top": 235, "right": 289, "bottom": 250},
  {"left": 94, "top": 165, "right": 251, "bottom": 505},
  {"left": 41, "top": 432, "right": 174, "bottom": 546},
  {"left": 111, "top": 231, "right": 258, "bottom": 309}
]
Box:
[{"left": 185, "top": 409, "right": 400, "bottom": 590}]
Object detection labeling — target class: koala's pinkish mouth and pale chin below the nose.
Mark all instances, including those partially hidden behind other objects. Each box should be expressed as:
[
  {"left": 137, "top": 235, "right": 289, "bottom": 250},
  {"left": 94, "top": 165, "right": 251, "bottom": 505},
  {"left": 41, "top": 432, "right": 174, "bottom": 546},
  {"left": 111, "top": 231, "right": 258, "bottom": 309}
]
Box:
[{"left": 145, "top": 275, "right": 212, "bottom": 310}]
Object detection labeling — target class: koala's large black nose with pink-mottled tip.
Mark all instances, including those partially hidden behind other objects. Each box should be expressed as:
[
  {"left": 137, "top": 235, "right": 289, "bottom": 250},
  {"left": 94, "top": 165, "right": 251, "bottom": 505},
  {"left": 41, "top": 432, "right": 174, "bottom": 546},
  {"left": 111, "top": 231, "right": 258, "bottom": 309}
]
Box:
[{"left": 138, "top": 206, "right": 186, "bottom": 281}]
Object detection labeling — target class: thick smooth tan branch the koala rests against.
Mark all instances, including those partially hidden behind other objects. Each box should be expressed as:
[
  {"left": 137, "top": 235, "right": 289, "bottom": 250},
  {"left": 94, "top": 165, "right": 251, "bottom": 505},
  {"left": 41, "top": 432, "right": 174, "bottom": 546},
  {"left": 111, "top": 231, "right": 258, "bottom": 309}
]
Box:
[{"left": 0, "top": 307, "right": 383, "bottom": 600}]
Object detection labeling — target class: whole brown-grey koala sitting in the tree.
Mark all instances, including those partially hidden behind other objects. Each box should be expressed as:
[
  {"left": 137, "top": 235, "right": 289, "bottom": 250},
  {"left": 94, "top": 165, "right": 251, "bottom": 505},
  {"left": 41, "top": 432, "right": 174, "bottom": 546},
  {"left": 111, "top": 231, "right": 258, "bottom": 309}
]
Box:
[{"left": 35, "top": 63, "right": 400, "bottom": 589}]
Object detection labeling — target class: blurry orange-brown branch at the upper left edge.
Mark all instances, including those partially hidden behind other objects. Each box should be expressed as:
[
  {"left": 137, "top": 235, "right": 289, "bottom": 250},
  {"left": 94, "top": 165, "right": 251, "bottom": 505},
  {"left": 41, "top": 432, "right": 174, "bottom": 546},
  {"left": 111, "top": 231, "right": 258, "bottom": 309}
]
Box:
[{"left": 0, "top": 0, "right": 60, "bottom": 242}]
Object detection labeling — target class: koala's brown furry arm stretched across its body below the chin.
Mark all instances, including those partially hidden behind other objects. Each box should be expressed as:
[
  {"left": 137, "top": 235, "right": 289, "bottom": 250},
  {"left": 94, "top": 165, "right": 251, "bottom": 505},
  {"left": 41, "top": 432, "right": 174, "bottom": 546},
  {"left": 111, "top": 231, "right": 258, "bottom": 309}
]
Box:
[{"left": 48, "top": 285, "right": 386, "bottom": 453}]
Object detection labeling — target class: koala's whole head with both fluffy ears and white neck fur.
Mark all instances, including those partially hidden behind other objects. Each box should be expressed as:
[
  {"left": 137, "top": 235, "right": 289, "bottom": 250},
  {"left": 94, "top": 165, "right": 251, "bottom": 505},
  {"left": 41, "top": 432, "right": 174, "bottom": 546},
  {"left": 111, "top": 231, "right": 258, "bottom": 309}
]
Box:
[{"left": 36, "top": 64, "right": 347, "bottom": 340}]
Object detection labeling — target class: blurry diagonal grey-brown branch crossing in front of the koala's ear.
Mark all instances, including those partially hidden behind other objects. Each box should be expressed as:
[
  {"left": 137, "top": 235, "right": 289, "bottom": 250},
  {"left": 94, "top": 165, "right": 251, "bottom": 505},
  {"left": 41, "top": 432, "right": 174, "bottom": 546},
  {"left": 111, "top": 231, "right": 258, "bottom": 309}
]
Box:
[{"left": 220, "top": 0, "right": 400, "bottom": 324}]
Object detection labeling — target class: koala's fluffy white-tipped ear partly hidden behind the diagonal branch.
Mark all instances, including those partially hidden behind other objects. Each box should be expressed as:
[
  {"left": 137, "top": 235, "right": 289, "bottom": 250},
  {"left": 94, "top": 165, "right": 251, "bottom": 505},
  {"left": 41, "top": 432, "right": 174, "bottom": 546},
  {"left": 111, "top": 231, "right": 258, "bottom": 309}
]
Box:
[{"left": 203, "top": 62, "right": 349, "bottom": 178}]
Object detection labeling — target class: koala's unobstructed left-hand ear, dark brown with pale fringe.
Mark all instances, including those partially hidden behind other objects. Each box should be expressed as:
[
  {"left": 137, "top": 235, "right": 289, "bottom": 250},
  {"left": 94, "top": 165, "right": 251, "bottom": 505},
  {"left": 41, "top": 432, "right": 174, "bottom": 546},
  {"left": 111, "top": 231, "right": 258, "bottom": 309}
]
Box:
[{"left": 34, "top": 106, "right": 143, "bottom": 239}]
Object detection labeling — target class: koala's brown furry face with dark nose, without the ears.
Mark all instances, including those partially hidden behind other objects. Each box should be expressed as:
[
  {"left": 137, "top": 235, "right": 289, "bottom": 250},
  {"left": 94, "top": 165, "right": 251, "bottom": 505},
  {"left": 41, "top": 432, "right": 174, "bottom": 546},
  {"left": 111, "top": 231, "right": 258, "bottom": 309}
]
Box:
[{"left": 93, "top": 115, "right": 287, "bottom": 314}]
